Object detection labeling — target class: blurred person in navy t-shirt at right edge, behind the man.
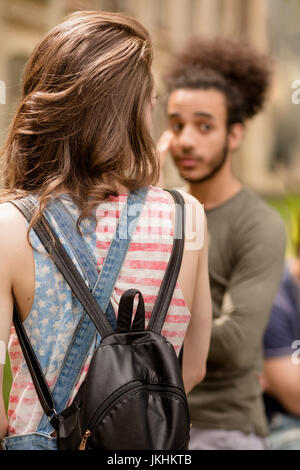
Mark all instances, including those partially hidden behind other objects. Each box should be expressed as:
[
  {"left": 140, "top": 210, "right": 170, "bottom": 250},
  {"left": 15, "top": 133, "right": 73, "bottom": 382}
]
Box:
[{"left": 262, "top": 244, "right": 300, "bottom": 450}]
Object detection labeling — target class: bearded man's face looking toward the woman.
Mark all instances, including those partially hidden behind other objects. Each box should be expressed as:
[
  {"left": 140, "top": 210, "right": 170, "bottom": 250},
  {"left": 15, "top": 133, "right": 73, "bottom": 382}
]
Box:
[{"left": 168, "top": 89, "right": 228, "bottom": 183}]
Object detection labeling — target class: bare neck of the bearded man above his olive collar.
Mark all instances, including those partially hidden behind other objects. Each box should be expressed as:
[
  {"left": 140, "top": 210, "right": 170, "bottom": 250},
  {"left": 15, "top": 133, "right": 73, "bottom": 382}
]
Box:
[{"left": 188, "top": 165, "right": 242, "bottom": 210}]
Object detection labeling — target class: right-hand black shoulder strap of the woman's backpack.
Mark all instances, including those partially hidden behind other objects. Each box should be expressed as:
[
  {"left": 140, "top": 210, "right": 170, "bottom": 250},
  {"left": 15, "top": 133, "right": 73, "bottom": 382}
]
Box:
[{"left": 147, "top": 189, "right": 185, "bottom": 334}]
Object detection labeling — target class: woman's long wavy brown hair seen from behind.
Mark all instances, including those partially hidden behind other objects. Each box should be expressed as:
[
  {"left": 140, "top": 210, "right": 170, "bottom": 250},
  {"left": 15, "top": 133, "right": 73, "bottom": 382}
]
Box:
[{"left": 1, "top": 11, "right": 159, "bottom": 228}]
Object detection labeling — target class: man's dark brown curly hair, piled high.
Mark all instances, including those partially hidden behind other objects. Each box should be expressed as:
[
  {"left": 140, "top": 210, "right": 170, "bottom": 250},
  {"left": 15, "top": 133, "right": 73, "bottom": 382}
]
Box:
[{"left": 164, "top": 38, "right": 271, "bottom": 126}]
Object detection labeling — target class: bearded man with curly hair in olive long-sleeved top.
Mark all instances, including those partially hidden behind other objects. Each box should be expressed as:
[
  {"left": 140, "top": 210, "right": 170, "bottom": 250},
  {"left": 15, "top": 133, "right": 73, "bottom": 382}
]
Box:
[{"left": 158, "top": 39, "right": 285, "bottom": 450}]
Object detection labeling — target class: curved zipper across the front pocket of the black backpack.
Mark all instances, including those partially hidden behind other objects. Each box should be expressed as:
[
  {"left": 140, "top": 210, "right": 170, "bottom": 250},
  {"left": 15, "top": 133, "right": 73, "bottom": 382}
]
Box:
[{"left": 78, "top": 381, "right": 186, "bottom": 450}]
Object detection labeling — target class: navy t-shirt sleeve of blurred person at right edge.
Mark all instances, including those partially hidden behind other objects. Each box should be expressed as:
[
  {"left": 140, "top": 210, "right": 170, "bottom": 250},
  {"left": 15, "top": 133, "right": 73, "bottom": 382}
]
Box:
[{"left": 264, "top": 278, "right": 296, "bottom": 359}]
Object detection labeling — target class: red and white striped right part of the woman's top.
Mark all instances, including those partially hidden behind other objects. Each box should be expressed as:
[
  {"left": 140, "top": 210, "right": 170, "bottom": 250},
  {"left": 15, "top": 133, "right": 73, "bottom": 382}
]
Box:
[{"left": 96, "top": 186, "right": 190, "bottom": 353}]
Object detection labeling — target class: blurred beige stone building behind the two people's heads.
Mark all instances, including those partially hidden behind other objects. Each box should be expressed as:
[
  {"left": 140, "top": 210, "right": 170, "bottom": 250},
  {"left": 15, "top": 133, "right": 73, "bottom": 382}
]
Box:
[{"left": 0, "top": 0, "right": 300, "bottom": 195}]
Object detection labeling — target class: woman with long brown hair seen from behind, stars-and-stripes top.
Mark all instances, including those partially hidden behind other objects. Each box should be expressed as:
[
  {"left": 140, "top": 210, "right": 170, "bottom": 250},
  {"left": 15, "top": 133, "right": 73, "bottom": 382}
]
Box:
[{"left": 0, "top": 11, "right": 211, "bottom": 449}]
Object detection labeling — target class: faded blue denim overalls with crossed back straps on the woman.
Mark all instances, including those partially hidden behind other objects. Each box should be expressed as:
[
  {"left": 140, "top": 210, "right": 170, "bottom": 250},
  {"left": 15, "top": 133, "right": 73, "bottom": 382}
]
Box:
[{"left": 1, "top": 188, "right": 148, "bottom": 450}]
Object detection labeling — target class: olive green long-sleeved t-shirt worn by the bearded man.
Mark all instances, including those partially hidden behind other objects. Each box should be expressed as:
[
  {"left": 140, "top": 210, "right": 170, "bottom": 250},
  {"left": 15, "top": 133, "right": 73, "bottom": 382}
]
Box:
[{"left": 188, "top": 188, "right": 285, "bottom": 436}]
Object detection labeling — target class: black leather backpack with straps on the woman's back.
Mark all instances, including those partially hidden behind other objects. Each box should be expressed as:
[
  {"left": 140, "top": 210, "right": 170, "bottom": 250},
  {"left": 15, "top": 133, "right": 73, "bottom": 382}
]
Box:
[{"left": 14, "top": 191, "right": 190, "bottom": 450}]
